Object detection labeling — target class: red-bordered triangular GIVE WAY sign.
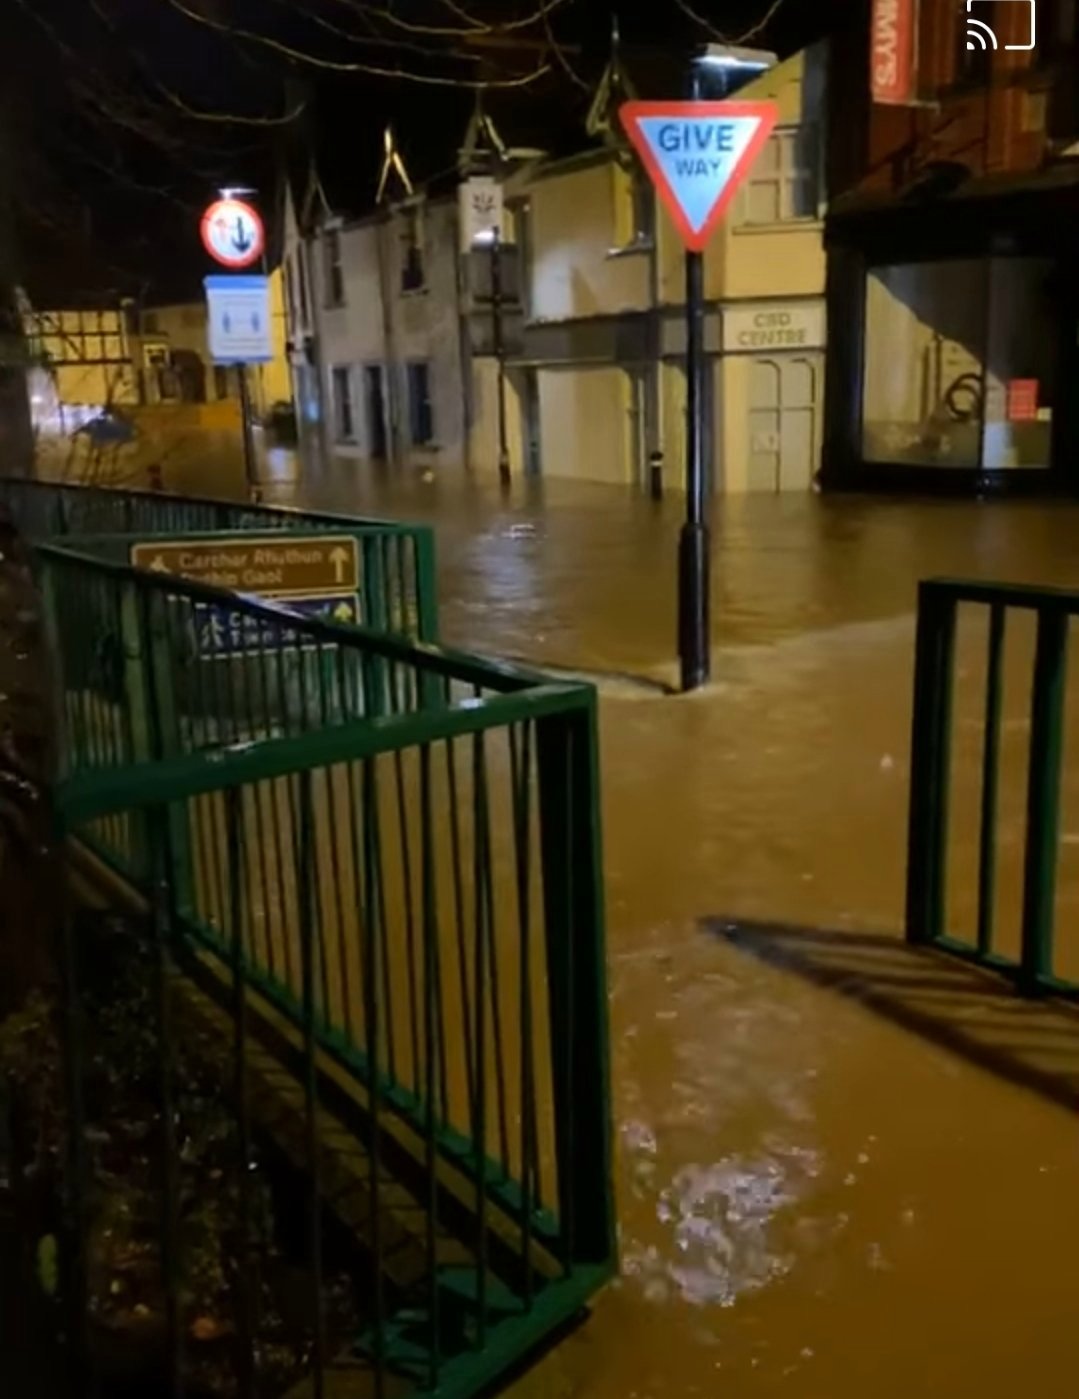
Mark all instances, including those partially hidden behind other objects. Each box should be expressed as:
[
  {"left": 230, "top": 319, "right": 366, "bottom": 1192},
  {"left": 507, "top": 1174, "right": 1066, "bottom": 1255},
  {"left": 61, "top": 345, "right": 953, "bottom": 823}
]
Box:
[{"left": 619, "top": 102, "right": 778, "bottom": 252}]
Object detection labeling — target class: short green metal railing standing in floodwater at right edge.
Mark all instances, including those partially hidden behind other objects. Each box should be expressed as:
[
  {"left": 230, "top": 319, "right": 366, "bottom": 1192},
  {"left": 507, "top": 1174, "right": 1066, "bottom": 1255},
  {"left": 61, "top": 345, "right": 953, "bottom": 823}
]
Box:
[{"left": 907, "top": 579, "right": 1079, "bottom": 996}]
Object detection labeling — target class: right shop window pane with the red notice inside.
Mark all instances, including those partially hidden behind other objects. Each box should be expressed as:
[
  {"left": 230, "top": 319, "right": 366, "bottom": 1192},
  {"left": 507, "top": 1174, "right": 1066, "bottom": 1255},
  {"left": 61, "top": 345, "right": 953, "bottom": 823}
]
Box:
[{"left": 984, "top": 257, "right": 1057, "bottom": 470}]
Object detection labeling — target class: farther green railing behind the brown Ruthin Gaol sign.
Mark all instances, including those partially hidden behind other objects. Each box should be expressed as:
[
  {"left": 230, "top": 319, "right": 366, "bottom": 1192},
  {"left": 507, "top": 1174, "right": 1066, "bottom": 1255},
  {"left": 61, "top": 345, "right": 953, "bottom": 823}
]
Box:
[{"left": 0, "top": 477, "right": 438, "bottom": 641}]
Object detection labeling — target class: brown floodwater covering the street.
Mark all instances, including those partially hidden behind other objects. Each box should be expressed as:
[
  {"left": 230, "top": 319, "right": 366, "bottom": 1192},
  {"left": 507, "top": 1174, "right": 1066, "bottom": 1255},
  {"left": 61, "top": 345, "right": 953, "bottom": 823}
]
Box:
[{"left": 52, "top": 439, "right": 1079, "bottom": 1399}]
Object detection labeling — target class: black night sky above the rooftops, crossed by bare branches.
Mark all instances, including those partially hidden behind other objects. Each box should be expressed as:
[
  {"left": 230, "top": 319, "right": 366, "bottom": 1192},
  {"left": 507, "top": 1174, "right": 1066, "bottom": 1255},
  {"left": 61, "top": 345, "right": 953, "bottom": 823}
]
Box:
[{"left": 0, "top": 0, "right": 862, "bottom": 305}]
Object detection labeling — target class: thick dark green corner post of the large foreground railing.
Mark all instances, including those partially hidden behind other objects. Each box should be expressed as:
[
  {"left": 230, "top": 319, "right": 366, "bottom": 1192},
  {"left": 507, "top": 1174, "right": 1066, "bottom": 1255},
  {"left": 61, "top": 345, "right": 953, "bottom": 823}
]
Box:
[{"left": 536, "top": 690, "right": 617, "bottom": 1272}]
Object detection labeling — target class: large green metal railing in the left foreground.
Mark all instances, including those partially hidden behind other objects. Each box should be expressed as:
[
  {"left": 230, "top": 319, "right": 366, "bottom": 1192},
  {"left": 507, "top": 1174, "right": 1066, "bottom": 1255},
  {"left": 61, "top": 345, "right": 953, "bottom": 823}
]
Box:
[{"left": 38, "top": 546, "right": 614, "bottom": 1395}]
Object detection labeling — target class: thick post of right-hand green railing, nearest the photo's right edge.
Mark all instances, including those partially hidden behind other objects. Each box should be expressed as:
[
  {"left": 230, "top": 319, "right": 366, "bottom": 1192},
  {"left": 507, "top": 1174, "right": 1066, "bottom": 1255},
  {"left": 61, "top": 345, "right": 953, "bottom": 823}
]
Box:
[{"left": 1020, "top": 606, "right": 1068, "bottom": 993}]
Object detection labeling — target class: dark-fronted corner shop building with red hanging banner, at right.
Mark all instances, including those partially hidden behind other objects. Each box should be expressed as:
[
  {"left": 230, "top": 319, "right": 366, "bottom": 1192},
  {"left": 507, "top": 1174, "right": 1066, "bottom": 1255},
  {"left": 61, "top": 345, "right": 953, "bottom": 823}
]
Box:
[{"left": 821, "top": 0, "right": 1079, "bottom": 494}]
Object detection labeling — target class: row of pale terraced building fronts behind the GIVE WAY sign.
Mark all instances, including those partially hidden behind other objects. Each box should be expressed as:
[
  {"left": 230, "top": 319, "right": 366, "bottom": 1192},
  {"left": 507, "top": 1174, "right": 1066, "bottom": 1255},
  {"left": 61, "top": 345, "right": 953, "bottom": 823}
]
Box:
[{"left": 285, "top": 48, "right": 826, "bottom": 491}]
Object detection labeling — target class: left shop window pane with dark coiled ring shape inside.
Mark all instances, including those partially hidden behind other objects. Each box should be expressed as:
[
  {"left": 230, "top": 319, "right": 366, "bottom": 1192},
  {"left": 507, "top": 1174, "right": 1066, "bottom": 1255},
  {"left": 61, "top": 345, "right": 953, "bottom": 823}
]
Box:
[{"left": 862, "top": 259, "right": 988, "bottom": 467}]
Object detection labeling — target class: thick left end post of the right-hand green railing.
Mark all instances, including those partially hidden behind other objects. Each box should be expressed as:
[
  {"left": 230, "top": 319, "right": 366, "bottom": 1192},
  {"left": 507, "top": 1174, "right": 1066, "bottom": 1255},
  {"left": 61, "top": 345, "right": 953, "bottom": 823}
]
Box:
[{"left": 907, "top": 582, "right": 956, "bottom": 943}]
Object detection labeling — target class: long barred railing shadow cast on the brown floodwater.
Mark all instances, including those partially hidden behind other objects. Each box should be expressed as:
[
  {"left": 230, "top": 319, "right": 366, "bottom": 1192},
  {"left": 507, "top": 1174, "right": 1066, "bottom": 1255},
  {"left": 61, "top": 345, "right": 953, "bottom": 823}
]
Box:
[{"left": 703, "top": 918, "right": 1079, "bottom": 1112}]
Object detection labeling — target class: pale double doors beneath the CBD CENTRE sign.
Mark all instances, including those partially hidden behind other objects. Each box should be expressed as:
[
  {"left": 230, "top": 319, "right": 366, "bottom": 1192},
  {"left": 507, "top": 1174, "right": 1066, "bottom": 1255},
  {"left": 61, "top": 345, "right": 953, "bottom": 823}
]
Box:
[{"left": 746, "top": 354, "right": 823, "bottom": 492}]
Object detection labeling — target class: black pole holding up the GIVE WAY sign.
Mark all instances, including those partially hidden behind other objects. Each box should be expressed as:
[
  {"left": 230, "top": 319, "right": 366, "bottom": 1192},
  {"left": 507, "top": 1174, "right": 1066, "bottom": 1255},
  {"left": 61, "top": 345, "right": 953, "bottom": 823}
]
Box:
[{"left": 679, "top": 64, "right": 711, "bottom": 690}]
